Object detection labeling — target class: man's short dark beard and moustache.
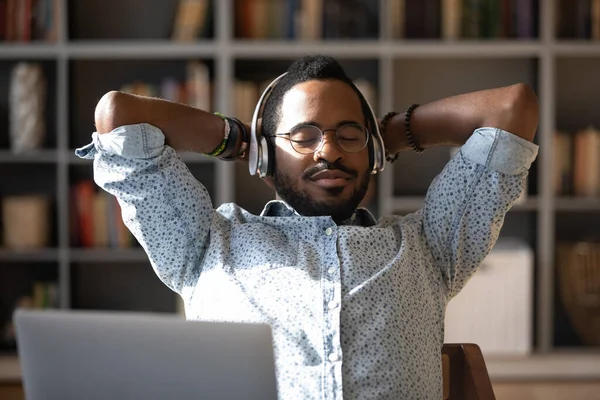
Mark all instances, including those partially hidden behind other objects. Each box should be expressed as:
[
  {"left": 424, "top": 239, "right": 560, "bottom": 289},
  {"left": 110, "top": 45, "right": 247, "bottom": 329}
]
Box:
[{"left": 273, "top": 161, "right": 370, "bottom": 223}]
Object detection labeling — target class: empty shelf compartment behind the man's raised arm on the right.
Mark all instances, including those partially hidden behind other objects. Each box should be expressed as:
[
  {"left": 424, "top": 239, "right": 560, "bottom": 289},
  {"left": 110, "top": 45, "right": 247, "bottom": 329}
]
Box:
[{"left": 393, "top": 57, "right": 538, "bottom": 196}]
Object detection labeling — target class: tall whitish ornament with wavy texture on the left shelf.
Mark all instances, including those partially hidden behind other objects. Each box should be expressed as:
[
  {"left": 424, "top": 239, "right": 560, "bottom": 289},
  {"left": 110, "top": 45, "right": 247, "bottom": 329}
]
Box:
[{"left": 9, "top": 62, "right": 46, "bottom": 153}]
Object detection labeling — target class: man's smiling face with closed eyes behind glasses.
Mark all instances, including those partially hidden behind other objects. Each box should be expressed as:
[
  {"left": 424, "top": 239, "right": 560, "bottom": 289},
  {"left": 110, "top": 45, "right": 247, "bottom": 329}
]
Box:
[{"left": 271, "top": 80, "right": 371, "bottom": 222}]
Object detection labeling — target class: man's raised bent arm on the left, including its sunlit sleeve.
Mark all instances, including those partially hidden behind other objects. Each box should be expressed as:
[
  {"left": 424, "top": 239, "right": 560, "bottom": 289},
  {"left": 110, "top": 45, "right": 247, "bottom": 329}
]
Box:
[{"left": 77, "top": 92, "right": 245, "bottom": 293}]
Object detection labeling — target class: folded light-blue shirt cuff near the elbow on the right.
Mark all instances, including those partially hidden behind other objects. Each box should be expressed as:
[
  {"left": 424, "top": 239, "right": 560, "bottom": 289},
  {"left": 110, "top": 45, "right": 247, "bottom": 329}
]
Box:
[{"left": 461, "top": 127, "right": 539, "bottom": 175}]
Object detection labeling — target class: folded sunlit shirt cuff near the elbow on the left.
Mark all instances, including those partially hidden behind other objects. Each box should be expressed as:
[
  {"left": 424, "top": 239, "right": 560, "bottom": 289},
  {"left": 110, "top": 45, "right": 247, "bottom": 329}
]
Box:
[{"left": 75, "top": 123, "right": 165, "bottom": 159}]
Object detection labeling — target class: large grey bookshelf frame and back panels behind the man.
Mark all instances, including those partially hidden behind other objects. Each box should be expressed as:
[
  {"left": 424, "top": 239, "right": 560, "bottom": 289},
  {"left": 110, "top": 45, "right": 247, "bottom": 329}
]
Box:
[{"left": 0, "top": 0, "right": 600, "bottom": 379}]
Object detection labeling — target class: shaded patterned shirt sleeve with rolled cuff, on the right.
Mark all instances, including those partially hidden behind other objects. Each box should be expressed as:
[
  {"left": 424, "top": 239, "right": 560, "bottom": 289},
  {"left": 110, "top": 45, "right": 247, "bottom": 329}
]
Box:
[{"left": 422, "top": 127, "right": 538, "bottom": 297}]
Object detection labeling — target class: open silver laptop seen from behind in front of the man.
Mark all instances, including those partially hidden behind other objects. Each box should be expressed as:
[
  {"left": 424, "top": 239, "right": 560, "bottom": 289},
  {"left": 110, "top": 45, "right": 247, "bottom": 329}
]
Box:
[{"left": 14, "top": 309, "right": 277, "bottom": 400}]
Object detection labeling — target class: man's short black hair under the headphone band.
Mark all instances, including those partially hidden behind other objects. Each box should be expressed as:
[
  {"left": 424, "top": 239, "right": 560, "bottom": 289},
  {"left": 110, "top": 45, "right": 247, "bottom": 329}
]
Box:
[{"left": 262, "top": 55, "right": 375, "bottom": 137}]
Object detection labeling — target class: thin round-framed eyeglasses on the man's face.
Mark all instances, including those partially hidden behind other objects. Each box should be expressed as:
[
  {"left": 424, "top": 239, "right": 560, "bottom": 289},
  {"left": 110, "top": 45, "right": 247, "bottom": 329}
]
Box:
[{"left": 271, "top": 124, "right": 369, "bottom": 154}]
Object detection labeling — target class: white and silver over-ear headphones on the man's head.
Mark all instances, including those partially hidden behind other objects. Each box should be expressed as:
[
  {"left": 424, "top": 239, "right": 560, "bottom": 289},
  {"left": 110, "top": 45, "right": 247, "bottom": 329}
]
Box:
[{"left": 248, "top": 72, "right": 385, "bottom": 178}]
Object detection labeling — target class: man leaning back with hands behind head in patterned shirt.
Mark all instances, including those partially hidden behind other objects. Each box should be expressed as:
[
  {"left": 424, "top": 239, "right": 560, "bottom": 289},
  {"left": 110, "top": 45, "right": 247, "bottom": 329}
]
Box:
[{"left": 78, "top": 56, "right": 538, "bottom": 399}]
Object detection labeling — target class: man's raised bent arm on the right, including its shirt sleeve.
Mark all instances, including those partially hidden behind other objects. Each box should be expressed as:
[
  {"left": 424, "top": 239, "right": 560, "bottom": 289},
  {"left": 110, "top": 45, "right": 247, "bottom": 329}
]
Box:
[{"left": 384, "top": 85, "right": 538, "bottom": 297}]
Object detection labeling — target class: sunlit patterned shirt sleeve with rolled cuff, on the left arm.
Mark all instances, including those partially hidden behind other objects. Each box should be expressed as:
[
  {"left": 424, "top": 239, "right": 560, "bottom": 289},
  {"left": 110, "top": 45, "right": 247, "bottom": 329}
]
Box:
[{"left": 76, "top": 124, "right": 214, "bottom": 293}]
